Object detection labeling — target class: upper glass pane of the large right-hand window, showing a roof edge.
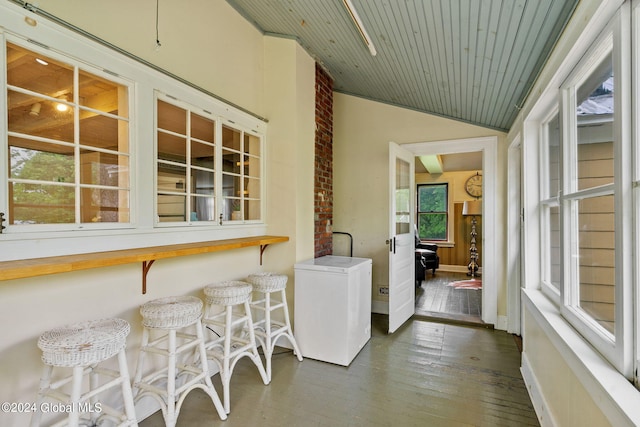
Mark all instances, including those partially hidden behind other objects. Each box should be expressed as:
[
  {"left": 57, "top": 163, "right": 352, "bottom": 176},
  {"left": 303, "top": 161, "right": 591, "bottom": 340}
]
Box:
[{"left": 576, "top": 55, "right": 614, "bottom": 190}]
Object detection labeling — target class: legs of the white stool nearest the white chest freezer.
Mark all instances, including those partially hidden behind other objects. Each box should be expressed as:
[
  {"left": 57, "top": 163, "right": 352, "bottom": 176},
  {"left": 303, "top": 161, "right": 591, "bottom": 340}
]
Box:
[{"left": 252, "top": 289, "right": 302, "bottom": 382}]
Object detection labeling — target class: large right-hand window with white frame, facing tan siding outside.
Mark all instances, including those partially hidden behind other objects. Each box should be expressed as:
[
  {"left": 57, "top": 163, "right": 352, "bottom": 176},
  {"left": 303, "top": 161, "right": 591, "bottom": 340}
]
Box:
[{"left": 556, "top": 7, "right": 633, "bottom": 377}]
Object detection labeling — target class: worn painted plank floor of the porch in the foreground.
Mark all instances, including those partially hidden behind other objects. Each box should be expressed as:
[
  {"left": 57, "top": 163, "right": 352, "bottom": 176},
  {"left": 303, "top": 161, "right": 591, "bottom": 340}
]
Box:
[{"left": 140, "top": 314, "right": 539, "bottom": 427}]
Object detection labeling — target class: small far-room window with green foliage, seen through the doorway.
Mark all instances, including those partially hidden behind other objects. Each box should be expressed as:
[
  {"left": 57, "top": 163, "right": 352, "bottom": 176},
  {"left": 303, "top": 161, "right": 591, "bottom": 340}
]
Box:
[{"left": 416, "top": 184, "right": 449, "bottom": 241}]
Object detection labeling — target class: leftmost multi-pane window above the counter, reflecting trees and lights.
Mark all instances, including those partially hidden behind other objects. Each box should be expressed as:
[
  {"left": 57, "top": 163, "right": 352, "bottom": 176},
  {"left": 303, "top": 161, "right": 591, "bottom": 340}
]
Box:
[{"left": 5, "top": 43, "right": 131, "bottom": 229}]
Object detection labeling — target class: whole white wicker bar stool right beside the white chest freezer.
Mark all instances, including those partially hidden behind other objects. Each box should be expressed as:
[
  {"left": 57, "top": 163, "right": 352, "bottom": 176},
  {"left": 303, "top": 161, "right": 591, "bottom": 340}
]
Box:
[{"left": 247, "top": 273, "right": 302, "bottom": 382}]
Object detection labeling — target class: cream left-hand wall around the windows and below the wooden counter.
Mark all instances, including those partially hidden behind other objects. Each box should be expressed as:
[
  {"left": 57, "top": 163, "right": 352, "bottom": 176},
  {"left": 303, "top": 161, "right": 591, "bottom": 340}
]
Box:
[{"left": 0, "top": 1, "right": 315, "bottom": 427}]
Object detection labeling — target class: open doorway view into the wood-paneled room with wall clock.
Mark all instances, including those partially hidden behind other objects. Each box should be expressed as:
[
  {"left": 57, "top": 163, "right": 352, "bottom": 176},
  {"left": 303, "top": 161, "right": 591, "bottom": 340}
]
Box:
[{"left": 415, "top": 151, "right": 484, "bottom": 324}]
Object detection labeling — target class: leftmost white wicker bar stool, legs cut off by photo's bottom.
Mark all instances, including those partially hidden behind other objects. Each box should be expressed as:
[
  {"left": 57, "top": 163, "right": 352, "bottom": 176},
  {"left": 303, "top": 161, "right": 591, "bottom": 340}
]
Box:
[{"left": 31, "top": 319, "right": 138, "bottom": 427}]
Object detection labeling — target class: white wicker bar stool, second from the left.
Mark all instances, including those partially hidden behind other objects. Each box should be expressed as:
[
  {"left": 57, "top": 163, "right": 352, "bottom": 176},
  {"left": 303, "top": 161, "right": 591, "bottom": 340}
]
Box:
[{"left": 133, "top": 296, "right": 227, "bottom": 427}]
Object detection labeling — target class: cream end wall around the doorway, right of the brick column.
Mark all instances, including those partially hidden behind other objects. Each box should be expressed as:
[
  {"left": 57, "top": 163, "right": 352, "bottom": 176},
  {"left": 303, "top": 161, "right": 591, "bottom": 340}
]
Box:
[{"left": 333, "top": 93, "right": 506, "bottom": 315}]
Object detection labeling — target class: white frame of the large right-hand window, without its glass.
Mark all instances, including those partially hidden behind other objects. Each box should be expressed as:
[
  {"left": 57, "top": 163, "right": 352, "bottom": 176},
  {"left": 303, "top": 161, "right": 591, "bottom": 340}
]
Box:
[{"left": 560, "top": 3, "right": 633, "bottom": 378}]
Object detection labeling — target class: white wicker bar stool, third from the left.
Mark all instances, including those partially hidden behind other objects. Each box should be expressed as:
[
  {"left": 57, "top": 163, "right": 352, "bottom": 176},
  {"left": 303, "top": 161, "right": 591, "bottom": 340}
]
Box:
[{"left": 202, "top": 280, "right": 269, "bottom": 414}]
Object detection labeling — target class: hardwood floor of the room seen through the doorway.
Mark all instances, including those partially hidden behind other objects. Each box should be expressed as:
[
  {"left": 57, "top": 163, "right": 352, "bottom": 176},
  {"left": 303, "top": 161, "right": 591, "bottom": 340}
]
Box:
[{"left": 416, "top": 270, "right": 484, "bottom": 325}]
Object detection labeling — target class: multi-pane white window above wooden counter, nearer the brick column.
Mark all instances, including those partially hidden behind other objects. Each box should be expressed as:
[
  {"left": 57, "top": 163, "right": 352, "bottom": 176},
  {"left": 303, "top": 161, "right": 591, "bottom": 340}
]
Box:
[{"left": 156, "top": 93, "right": 264, "bottom": 226}]
